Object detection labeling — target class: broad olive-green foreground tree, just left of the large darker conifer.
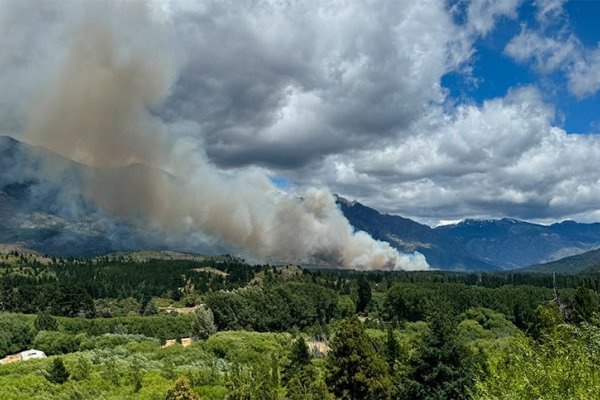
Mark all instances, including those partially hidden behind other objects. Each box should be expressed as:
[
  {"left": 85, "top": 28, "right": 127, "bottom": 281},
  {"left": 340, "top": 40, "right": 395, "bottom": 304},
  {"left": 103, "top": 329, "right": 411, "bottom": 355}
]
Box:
[{"left": 326, "top": 316, "right": 393, "bottom": 400}]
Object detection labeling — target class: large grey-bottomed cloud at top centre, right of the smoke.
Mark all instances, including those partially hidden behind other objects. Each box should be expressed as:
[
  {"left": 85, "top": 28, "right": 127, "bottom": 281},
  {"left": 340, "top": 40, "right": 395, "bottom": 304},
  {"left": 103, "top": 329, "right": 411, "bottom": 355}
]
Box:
[{"left": 164, "top": 1, "right": 471, "bottom": 168}]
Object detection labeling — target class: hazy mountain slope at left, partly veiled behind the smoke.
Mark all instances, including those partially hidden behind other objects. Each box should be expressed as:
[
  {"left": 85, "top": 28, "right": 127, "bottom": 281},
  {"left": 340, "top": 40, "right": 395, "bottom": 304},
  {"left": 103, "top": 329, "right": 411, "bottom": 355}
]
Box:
[{"left": 0, "top": 136, "right": 171, "bottom": 257}]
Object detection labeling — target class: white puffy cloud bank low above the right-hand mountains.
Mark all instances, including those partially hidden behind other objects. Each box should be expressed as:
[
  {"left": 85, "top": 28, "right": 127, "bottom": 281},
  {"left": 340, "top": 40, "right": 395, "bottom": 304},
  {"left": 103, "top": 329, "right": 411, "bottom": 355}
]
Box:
[{"left": 314, "top": 87, "right": 600, "bottom": 223}]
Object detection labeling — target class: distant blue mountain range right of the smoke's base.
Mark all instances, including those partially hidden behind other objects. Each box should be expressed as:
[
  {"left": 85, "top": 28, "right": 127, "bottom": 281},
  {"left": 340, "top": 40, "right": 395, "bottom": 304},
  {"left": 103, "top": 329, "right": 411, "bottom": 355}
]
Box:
[{"left": 337, "top": 197, "right": 600, "bottom": 271}]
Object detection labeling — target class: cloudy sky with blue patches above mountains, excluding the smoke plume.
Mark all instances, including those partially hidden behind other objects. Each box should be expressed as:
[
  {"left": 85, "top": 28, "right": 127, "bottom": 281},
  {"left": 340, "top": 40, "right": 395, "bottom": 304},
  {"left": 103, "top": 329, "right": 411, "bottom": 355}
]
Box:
[{"left": 0, "top": 0, "right": 600, "bottom": 225}]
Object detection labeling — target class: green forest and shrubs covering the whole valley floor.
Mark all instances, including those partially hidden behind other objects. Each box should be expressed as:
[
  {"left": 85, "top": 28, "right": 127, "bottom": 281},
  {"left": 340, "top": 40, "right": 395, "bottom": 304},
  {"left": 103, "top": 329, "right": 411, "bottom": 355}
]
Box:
[{"left": 0, "top": 251, "right": 600, "bottom": 400}]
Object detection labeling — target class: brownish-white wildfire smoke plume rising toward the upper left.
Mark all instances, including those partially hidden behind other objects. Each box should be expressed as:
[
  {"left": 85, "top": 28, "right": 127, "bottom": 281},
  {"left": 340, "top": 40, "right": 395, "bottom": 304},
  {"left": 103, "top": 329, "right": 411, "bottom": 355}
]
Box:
[{"left": 14, "top": 2, "right": 428, "bottom": 269}]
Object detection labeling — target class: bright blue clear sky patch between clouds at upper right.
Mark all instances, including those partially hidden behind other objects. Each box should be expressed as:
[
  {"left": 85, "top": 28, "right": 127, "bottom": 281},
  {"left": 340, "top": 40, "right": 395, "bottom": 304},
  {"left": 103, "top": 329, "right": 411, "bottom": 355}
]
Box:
[{"left": 442, "top": 0, "right": 600, "bottom": 134}]
